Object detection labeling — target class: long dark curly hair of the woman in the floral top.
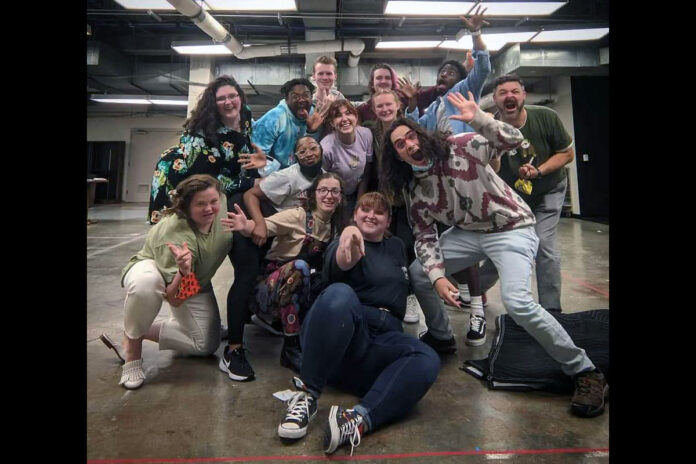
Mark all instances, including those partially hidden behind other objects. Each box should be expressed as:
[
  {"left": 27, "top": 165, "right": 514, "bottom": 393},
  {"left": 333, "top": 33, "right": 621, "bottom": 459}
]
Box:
[{"left": 184, "top": 75, "right": 251, "bottom": 146}]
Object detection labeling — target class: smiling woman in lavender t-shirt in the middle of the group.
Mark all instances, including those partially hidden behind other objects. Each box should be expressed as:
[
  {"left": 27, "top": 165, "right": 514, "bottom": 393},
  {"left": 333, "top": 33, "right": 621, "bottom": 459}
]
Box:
[{"left": 321, "top": 99, "right": 373, "bottom": 214}]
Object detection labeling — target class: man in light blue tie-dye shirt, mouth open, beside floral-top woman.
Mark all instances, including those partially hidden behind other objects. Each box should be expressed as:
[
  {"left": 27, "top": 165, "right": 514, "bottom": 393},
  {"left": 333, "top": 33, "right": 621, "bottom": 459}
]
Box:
[{"left": 251, "top": 78, "right": 318, "bottom": 175}]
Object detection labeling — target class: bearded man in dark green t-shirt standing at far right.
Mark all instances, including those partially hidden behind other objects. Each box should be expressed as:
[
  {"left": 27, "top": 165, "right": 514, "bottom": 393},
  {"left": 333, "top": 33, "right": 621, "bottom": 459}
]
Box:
[{"left": 480, "top": 74, "right": 575, "bottom": 311}]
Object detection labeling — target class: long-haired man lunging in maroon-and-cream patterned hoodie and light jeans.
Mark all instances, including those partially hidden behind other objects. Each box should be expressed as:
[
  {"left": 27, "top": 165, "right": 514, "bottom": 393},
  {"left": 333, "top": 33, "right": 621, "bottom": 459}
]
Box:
[{"left": 382, "top": 92, "right": 609, "bottom": 417}]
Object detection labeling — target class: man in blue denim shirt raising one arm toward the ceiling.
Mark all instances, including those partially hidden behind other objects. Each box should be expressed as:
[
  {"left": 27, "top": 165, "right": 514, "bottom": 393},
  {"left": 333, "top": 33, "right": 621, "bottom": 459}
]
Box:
[{"left": 401, "top": 6, "right": 491, "bottom": 134}]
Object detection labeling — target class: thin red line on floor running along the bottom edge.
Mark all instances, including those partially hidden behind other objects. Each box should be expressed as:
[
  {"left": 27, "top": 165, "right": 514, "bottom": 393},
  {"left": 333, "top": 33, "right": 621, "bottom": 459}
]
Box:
[{"left": 87, "top": 448, "right": 609, "bottom": 464}]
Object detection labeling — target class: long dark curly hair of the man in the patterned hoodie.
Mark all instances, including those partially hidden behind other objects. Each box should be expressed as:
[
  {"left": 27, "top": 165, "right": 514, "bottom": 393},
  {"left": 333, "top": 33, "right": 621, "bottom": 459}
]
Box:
[{"left": 380, "top": 118, "right": 450, "bottom": 194}]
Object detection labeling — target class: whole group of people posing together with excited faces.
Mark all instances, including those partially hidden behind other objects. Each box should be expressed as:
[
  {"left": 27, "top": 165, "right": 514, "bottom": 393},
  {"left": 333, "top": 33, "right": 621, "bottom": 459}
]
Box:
[{"left": 104, "top": 8, "right": 608, "bottom": 453}]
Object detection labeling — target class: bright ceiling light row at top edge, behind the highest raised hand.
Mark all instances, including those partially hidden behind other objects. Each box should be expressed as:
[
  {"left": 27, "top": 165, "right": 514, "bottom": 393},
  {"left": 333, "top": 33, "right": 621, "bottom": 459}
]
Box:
[{"left": 384, "top": 0, "right": 566, "bottom": 16}]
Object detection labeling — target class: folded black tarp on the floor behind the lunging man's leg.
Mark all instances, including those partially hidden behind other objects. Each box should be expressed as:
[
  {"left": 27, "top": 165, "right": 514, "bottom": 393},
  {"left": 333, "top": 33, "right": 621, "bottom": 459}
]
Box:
[{"left": 460, "top": 309, "right": 609, "bottom": 393}]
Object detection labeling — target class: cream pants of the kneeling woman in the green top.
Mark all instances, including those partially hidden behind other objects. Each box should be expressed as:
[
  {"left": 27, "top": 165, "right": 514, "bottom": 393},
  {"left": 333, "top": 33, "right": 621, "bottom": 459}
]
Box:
[{"left": 123, "top": 259, "right": 220, "bottom": 356}]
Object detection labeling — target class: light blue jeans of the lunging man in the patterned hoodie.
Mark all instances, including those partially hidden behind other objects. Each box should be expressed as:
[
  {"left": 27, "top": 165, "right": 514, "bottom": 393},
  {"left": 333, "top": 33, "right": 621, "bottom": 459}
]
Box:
[{"left": 409, "top": 226, "right": 594, "bottom": 375}]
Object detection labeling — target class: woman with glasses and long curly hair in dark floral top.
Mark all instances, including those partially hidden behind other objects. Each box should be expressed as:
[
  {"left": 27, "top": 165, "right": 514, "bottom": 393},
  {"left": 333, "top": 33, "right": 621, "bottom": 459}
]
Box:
[{"left": 148, "top": 76, "right": 274, "bottom": 224}]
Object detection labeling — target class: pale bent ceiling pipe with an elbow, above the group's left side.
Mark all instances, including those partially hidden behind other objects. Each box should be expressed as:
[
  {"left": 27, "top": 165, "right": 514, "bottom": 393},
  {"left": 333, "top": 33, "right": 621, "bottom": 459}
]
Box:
[{"left": 167, "top": 0, "right": 365, "bottom": 68}]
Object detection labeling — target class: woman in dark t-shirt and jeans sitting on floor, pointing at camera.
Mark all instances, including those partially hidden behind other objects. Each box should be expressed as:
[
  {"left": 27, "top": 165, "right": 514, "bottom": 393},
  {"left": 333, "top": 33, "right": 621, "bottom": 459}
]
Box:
[{"left": 278, "top": 192, "right": 440, "bottom": 454}]
